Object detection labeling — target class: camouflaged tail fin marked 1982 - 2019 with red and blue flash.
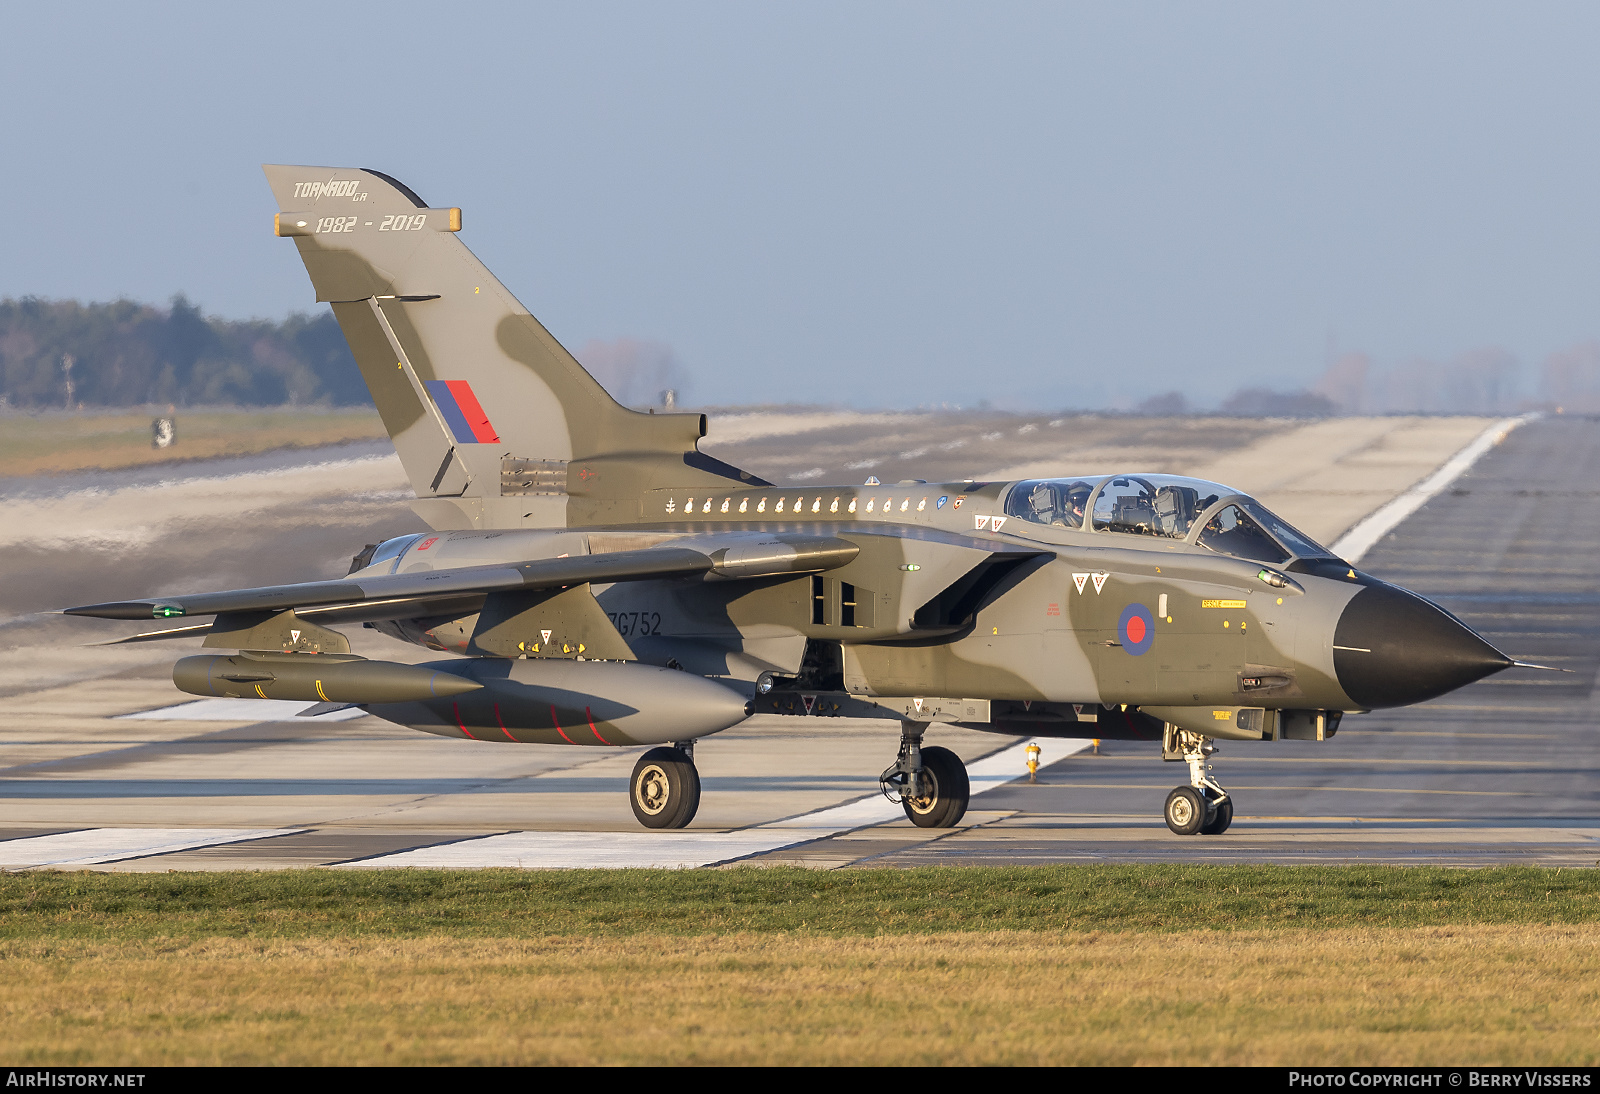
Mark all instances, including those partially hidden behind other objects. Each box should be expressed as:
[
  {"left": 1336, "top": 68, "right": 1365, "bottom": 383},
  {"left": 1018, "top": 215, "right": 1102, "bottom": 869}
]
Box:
[{"left": 262, "top": 165, "right": 762, "bottom": 528}]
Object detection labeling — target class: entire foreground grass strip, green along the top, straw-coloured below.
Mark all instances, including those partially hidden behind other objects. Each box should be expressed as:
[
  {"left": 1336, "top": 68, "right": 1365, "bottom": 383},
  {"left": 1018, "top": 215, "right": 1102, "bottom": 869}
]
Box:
[{"left": 0, "top": 865, "right": 1600, "bottom": 1065}]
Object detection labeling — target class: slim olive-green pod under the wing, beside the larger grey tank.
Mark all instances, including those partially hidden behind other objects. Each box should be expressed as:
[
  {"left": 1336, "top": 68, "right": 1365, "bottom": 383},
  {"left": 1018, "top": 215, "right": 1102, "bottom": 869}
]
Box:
[{"left": 173, "top": 653, "right": 483, "bottom": 705}]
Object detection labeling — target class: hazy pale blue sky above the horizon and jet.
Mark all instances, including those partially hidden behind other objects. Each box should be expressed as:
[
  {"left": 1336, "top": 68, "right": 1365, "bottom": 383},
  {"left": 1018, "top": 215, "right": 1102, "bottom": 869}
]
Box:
[{"left": 0, "top": 0, "right": 1600, "bottom": 409}]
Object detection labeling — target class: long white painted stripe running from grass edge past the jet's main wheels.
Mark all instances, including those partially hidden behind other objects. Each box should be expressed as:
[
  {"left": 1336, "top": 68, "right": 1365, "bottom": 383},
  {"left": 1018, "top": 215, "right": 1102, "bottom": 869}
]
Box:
[{"left": 350, "top": 741, "right": 1090, "bottom": 870}]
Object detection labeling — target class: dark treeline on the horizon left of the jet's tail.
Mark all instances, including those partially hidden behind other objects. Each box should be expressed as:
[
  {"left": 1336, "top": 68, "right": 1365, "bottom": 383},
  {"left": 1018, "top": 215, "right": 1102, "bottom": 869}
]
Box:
[{"left": 0, "top": 296, "right": 371, "bottom": 409}]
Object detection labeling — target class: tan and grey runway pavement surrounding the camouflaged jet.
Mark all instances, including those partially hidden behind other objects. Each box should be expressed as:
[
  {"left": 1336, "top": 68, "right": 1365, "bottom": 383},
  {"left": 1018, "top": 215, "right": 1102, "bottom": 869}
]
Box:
[{"left": 0, "top": 417, "right": 1600, "bottom": 870}]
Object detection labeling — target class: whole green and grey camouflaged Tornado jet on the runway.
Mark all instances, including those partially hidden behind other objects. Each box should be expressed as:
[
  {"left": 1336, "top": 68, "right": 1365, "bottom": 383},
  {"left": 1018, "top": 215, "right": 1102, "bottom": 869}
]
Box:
[{"left": 69, "top": 166, "right": 1536, "bottom": 835}]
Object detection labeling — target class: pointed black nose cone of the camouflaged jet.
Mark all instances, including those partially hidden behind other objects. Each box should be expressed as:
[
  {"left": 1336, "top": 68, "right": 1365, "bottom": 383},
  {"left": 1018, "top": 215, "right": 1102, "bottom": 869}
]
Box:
[{"left": 1333, "top": 585, "right": 1512, "bottom": 709}]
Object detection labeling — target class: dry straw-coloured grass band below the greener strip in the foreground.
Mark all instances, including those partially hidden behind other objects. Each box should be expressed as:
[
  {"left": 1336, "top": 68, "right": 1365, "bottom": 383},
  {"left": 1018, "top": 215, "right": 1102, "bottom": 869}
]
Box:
[{"left": 0, "top": 926, "right": 1600, "bottom": 1065}]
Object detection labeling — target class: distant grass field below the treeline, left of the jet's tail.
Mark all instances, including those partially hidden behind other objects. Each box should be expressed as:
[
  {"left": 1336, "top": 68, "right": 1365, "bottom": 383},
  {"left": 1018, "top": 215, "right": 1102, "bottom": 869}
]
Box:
[{"left": 0, "top": 409, "right": 384, "bottom": 477}]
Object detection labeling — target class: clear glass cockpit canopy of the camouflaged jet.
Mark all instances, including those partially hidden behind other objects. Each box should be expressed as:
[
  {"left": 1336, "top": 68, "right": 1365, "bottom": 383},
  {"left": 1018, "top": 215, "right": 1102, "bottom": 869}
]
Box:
[{"left": 1005, "top": 475, "right": 1333, "bottom": 566}]
